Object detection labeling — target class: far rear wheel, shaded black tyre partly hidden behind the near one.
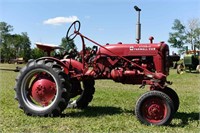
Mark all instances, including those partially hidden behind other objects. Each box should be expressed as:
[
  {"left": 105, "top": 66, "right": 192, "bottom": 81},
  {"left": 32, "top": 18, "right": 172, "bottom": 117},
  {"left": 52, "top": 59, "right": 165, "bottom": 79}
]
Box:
[{"left": 68, "top": 78, "right": 95, "bottom": 109}]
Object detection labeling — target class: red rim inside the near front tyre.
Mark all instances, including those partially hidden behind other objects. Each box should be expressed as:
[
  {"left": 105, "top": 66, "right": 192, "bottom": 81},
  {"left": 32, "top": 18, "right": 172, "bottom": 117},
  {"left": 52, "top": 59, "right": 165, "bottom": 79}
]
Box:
[{"left": 142, "top": 97, "right": 167, "bottom": 123}]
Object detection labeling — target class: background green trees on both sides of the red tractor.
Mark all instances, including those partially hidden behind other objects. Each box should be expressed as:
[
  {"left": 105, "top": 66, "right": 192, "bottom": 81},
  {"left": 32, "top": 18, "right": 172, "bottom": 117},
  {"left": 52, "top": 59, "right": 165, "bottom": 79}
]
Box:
[{"left": 0, "top": 19, "right": 200, "bottom": 62}]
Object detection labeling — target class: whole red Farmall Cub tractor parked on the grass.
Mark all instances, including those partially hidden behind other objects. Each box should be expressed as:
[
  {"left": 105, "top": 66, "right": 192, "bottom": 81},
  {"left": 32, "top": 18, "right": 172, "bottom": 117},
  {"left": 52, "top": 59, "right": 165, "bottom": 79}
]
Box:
[{"left": 14, "top": 6, "right": 179, "bottom": 125}]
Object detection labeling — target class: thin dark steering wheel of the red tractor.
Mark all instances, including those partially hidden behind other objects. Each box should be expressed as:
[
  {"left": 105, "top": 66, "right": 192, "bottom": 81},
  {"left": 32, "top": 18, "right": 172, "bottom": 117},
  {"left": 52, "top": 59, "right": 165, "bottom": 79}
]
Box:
[{"left": 66, "top": 20, "right": 81, "bottom": 41}]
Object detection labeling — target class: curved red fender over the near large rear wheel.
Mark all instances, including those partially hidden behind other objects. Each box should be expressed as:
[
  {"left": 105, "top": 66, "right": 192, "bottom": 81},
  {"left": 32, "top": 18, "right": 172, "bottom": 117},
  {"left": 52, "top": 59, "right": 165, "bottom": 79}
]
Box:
[{"left": 36, "top": 57, "right": 69, "bottom": 74}]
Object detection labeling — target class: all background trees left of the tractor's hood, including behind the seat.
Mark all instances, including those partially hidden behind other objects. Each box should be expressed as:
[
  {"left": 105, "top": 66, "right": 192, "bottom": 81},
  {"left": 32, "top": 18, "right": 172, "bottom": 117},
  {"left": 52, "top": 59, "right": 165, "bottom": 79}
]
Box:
[{"left": 0, "top": 22, "right": 77, "bottom": 63}]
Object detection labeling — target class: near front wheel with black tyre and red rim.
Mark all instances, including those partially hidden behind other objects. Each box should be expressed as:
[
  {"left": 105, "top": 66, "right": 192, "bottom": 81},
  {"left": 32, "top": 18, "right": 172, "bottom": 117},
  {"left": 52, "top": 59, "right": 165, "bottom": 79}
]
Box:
[{"left": 135, "top": 90, "right": 174, "bottom": 125}]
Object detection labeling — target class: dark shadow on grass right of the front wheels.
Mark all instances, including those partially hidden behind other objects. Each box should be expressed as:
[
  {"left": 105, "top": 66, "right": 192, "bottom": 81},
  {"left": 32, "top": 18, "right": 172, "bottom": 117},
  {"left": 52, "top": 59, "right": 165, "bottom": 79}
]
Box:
[{"left": 172, "top": 112, "right": 200, "bottom": 127}]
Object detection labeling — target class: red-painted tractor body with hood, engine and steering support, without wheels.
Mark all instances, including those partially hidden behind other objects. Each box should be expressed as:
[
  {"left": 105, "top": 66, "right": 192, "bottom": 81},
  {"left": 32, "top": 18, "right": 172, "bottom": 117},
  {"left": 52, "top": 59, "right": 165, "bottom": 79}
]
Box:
[{"left": 35, "top": 22, "right": 169, "bottom": 89}]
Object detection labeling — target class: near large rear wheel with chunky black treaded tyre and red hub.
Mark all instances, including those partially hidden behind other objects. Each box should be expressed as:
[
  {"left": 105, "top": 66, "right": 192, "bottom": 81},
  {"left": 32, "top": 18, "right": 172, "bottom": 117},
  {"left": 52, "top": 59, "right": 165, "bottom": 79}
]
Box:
[{"left": 14, "top": 60, "right": 70, "bottom": 116}]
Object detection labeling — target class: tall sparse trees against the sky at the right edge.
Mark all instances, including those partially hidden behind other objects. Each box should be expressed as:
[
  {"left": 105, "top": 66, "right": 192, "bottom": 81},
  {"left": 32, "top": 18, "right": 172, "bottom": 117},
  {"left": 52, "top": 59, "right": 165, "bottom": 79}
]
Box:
[{"left": 168, "top": 19, "right": 200, "bottom": 52}]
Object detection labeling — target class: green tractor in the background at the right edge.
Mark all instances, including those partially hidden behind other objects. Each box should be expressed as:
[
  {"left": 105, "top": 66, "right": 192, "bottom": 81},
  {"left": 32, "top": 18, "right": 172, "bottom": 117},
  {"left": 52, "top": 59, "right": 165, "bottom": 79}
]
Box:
[{"left": 177, "top": 50, "right": 200, "bottom": 74}]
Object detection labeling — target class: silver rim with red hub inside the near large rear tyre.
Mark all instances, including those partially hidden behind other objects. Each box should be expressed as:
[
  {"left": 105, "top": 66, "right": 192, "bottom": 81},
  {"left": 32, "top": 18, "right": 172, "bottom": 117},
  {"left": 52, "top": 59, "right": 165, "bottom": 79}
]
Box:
[{"left": 21, "top": 69, "right": 58, "bottom": 111}]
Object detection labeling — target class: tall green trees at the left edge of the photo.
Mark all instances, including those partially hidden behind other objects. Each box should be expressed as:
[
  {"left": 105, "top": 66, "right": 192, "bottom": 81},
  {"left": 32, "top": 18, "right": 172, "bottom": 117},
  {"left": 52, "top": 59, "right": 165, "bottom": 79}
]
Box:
[{"left": 0, "top": 22, "right": 31, "bottom": 62}]
